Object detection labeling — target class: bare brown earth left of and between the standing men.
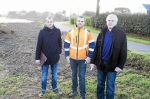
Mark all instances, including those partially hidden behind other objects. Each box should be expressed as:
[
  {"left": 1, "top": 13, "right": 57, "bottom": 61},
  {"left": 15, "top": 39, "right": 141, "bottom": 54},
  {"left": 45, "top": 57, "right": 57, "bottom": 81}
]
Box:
[{"left": 0, "top": 23, "right": 96, "bottom": 99}]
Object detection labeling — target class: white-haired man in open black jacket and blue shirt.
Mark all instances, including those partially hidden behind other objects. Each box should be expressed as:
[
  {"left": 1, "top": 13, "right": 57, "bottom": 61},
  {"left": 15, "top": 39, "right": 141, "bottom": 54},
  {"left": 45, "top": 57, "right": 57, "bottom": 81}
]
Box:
[{"left": 90, "top": 14, "right": 127, "bottom": 99}]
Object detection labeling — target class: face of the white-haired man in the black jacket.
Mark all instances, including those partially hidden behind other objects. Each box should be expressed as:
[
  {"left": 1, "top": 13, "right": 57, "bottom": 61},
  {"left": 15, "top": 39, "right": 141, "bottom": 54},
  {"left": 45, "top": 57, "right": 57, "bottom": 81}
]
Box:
[{"left": 106, "top": 16, "right": 117, "bottom": 29}]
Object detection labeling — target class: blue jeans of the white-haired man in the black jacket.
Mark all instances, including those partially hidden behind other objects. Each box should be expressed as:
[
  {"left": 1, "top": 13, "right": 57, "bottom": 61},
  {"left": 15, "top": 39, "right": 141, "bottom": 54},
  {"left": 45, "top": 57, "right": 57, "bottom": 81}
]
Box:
[{"left": 97, "top": 70, "right": 117, "bottom": 99}]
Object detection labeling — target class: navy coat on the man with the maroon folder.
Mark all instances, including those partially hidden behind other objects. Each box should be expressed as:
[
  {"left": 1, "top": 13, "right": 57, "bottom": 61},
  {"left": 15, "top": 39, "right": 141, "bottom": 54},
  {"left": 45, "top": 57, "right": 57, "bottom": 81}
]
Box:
[{"left": 35, "top": 26, "right": 62, "bottom": 65}]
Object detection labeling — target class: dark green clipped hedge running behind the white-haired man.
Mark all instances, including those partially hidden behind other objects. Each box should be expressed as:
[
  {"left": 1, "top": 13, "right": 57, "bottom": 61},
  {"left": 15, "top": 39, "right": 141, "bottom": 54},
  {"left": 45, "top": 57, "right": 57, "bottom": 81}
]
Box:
[{"left": 91, "top": 13, "right": 150, "bottom": 36}]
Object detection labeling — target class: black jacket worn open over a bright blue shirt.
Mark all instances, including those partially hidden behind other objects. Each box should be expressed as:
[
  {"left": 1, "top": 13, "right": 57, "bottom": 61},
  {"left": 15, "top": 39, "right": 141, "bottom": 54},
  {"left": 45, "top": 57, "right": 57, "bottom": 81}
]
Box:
[{"left": 91, "top": 26, "right": 127, "bottom": 72}]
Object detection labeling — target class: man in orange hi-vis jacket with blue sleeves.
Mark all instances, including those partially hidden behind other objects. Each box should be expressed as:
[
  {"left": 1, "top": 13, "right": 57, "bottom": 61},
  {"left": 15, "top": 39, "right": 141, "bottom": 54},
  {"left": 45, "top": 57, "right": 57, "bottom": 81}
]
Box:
[{"left": 64, "top": 16, "right": 95, "bottom": 99}]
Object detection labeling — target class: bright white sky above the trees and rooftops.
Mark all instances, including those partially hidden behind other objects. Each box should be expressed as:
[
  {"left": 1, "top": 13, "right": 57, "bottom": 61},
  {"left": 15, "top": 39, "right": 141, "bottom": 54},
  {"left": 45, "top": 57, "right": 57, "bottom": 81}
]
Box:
[{"left": 0, "top": 0, "right": 150, "bottom": 16}]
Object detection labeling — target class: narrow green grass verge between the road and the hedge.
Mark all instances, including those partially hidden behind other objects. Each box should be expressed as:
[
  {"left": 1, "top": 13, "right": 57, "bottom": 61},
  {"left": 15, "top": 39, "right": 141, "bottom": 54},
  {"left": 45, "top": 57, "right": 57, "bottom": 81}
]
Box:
[{"left": 64, "top": 23, "right": 150, "bottom": 45}]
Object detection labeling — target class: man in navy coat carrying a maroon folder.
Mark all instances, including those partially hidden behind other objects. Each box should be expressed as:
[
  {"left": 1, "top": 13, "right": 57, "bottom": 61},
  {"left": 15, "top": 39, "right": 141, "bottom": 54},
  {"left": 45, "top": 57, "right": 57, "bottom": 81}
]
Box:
[{"left": 35, "top": 17, "right": 62, "bottom": 97}]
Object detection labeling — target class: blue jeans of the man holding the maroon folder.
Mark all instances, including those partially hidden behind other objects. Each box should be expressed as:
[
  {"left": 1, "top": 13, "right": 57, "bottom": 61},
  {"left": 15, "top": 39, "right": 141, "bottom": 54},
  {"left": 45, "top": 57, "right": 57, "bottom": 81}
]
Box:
[{"left": 41, "top": 63, "right": 58, "bottom": 92}]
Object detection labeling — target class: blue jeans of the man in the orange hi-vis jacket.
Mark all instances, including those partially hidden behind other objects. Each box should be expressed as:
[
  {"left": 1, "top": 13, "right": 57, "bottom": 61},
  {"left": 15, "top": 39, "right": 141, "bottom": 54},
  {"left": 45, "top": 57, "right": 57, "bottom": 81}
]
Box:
[{"left": 70, "top": 58, "right": 86, "bottom": 98}]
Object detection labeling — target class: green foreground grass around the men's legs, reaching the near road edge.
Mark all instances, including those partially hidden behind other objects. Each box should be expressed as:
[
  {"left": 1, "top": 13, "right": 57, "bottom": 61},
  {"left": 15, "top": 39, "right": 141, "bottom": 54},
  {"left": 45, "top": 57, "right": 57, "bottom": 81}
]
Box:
[{"left": 43, "top": 50, "right": 150, "bottom": 99}]
